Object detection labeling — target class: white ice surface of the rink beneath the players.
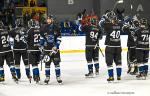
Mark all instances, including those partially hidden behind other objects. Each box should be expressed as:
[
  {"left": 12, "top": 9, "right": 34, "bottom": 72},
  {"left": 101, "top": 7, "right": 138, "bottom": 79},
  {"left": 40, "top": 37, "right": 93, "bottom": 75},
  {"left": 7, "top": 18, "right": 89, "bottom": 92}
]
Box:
[{"left": 0, "top": 52, "right": 150, "bottom": 96}]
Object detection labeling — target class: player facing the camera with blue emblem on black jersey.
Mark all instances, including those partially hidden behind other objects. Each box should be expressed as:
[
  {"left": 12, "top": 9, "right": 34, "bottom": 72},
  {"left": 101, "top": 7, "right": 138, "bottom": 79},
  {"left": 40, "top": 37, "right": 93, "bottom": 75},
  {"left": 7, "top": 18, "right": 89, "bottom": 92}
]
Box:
[{"left": 41, "top": 15, "right": 62, "bottom": 83}]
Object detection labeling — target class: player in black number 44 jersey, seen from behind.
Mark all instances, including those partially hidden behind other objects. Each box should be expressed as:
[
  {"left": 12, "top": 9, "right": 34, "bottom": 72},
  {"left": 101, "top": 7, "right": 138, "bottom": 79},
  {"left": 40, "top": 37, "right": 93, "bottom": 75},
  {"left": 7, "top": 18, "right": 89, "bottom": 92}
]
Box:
[{"left": 11, "top": 19, "right": 31, "bottom": 80}]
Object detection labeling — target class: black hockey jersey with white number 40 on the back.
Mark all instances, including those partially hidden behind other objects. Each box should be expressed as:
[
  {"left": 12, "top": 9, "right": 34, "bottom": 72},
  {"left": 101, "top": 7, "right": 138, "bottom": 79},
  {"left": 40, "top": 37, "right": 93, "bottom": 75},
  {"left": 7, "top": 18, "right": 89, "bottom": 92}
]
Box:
[{"left": 104, "top": 22, "right": 122, "bottom": 47}]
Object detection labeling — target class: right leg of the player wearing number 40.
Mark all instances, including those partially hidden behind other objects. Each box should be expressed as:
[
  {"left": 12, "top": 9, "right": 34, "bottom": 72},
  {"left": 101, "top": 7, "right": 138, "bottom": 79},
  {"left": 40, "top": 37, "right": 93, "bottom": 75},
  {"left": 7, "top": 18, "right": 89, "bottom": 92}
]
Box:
[{"left": 114, "top": 47, "right": 122, "bottom": 80}]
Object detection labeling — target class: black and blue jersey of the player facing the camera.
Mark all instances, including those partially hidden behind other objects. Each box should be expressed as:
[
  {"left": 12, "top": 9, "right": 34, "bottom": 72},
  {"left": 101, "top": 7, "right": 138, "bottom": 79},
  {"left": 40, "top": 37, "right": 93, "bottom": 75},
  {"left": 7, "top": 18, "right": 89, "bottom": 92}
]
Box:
[{"left": 41, "top": 24, "right": 61, "bottom": 50}]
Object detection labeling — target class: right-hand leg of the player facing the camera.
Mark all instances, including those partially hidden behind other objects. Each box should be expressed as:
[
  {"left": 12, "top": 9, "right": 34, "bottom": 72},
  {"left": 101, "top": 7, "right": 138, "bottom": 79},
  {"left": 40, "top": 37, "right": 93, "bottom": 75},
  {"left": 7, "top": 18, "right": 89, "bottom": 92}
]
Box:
[{"left": 53, "top": 51, "right": 62, "bottom": 83}]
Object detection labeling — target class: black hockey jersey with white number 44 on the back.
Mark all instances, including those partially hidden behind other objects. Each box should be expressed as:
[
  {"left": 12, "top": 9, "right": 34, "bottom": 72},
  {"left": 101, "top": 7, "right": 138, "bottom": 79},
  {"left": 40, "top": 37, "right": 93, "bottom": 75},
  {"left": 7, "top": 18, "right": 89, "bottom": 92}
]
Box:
[{"left": 10, "top": 27, "right": 27, "bottom": 50}]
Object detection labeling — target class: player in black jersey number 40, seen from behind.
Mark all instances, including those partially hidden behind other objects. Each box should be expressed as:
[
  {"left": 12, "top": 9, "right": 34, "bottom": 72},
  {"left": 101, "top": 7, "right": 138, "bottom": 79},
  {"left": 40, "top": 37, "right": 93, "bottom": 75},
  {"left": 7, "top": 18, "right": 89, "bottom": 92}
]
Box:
[{"left": 101, "top": 12, "right": 122, "bottom": 81}]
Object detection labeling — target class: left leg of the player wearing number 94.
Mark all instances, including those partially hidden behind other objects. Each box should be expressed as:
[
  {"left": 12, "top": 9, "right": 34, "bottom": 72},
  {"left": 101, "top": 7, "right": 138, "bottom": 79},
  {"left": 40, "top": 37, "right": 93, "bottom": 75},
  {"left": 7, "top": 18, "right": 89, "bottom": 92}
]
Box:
[{"left": 85, "top": 47, "right": 94, "bottom": 77}]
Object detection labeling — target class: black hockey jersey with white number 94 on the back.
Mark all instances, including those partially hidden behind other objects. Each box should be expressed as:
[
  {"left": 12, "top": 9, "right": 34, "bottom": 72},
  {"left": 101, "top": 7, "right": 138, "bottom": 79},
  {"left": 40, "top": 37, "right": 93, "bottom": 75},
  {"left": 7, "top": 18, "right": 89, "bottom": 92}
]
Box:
[{"left": 82, "top": 26, "right": 102, "bottom": 47}]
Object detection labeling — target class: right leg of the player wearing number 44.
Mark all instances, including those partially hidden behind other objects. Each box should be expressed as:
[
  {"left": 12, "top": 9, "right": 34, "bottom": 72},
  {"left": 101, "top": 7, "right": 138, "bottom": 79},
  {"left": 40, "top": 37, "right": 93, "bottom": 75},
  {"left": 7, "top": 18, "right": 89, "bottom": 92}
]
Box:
[{"left": 22, "top": 50, "right": 31, "bottom": 79}]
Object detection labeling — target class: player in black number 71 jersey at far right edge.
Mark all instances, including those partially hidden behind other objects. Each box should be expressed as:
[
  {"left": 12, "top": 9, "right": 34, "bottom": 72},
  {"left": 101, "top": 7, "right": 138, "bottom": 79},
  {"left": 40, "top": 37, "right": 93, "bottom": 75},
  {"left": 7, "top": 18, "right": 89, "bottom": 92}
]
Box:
[{"left": 135, "top": 18, "right": 150, "bottom": 79}]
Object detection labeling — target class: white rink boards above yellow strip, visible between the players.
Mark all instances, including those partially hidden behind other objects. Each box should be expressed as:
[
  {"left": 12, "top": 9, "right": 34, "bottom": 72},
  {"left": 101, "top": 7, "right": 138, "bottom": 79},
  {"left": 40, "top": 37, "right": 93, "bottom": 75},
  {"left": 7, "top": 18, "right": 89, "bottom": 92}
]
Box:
[{"left": 60, "top": 35, "right": 127, "bottom": 50}]
